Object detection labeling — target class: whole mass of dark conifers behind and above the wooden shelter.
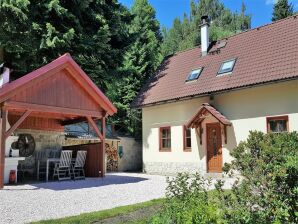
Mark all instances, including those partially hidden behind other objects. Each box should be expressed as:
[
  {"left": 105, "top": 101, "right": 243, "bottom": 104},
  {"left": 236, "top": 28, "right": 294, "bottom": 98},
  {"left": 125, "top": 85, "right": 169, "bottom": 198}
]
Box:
[{"left": 0, "top": 0, "right": 162, "bottom": 136}]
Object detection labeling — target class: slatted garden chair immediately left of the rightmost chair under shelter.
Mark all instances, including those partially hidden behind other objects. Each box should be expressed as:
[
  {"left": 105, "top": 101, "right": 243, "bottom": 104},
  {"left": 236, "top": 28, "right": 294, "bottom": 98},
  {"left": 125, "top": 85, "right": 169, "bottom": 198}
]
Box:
[{"left": 53, "top": 150, "right": 72, "bottom": 181}]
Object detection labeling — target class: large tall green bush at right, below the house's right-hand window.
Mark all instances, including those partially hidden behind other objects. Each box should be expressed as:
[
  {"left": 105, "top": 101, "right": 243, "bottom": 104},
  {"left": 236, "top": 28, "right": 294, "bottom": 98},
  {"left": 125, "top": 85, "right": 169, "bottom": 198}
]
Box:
[{"left": 217, "top": 131, "right": 298, "bottom": 223}]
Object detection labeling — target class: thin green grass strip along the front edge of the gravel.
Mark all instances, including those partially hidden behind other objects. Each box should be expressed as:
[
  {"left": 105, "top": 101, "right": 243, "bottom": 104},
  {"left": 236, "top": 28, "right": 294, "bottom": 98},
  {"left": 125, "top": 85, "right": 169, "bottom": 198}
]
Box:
[{"left": 33, "top": 198, "right": 165, "bottom": 224}]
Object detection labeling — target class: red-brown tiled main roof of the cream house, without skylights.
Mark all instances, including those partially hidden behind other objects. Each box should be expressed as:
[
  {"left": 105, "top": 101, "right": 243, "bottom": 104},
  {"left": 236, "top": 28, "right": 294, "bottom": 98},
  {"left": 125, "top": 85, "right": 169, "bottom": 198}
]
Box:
[{"left": 134, "top": 16, "right": 298, "bottom": 106}]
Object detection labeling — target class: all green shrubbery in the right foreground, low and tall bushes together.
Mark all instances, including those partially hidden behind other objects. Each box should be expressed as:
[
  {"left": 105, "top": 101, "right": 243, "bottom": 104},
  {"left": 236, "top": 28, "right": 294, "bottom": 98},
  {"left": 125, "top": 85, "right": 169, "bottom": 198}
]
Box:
[{"left": 152, "top": 131, "right": 298, "bottom": 224}]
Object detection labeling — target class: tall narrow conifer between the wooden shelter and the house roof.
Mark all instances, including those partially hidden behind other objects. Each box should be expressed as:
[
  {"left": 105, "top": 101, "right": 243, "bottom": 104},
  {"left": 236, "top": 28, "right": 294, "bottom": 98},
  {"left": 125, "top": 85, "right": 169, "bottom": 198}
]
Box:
[{"left": 108, "top": 0, "right": 162, "bottom": 134}]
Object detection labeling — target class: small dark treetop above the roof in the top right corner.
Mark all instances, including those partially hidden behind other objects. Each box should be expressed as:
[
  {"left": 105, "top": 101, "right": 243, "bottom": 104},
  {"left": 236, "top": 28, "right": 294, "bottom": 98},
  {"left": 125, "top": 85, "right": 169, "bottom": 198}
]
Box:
[{"left": 272, "top": 0, "right": 293, "bottom": 21}]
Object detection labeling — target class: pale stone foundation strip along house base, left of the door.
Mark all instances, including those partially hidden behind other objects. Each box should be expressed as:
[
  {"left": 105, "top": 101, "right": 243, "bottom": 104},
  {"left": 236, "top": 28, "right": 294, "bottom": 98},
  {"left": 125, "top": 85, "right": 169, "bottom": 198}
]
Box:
[{"left": 143, "top": 162, "right": 205, "bottom": 176}]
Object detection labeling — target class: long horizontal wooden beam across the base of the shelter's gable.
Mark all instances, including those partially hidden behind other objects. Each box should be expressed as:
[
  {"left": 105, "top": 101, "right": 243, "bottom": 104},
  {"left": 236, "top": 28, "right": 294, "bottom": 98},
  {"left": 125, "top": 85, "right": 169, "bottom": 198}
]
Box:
[{"left": 4, "top": 101, "right": 102, "bottom": 117}]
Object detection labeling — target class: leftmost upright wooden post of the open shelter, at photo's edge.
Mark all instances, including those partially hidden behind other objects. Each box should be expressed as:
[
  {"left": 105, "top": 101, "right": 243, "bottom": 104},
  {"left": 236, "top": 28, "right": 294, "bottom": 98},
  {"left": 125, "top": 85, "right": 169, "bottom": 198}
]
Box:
[{"left": 0, "top": 107, "right": 7, "bottom": 189}]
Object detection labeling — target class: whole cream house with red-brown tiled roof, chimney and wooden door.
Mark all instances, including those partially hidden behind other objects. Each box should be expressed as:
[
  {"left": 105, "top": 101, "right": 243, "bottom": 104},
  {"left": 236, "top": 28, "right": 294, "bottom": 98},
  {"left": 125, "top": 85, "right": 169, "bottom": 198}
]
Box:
[{"left": 136, "top": 16, "right": 298, "bottom": 177}]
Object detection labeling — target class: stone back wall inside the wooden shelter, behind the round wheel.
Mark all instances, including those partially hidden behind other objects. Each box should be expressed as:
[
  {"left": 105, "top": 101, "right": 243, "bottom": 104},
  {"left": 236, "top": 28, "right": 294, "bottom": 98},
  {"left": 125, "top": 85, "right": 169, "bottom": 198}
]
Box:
[{"left": 14, "top": 129, "right": 65, "bottom": 174}]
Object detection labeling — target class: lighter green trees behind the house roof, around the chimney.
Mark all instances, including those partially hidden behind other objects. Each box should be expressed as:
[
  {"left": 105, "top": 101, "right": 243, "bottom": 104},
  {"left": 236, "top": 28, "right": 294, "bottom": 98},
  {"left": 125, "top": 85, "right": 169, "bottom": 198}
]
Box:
[{"left": 162, "top": 0, "right": 251, "bottom": 56}]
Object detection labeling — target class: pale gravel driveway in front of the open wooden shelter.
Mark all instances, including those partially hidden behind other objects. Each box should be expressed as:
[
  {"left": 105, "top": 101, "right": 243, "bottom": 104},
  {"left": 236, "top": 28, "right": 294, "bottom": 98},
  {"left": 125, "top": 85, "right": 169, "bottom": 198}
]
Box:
[{"left": 0, "top": 173, "right": 166, "bottom": 224}]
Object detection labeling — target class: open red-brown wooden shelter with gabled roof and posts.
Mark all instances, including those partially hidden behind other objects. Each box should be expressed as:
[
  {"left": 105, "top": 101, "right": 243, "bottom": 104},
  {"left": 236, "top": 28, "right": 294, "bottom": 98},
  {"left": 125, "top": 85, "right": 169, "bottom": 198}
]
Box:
[{"left": 0, "top": 54, "right": 117, "bottom": 189}]
